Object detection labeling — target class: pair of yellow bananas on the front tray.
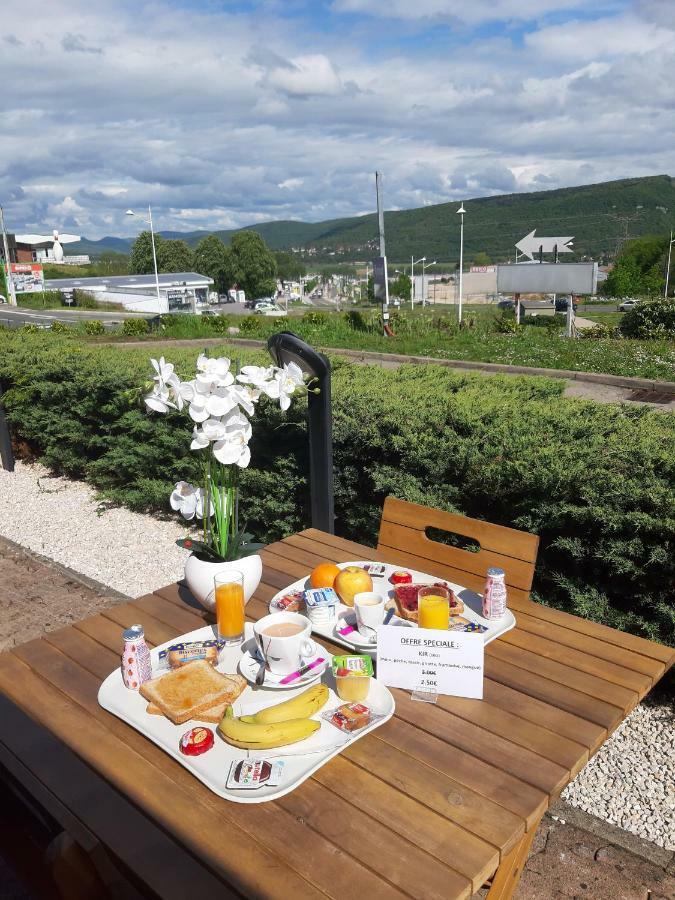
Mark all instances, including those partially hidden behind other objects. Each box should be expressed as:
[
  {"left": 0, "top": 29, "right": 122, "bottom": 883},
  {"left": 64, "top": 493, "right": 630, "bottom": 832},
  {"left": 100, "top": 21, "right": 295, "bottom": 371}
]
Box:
[{"left": 218, "top": 684, "right": 328, "bottom": 750}]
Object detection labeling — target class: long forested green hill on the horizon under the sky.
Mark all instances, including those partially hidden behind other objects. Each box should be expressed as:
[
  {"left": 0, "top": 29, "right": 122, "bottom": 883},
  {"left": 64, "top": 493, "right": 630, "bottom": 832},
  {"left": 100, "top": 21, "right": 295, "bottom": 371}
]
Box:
[{"left": 68, "top": 175, "right": 675, "bottom": 261}]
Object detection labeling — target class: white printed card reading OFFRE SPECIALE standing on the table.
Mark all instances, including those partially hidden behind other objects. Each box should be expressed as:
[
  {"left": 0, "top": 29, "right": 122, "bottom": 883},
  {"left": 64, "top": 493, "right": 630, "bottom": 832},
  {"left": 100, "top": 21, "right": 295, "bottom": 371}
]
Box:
[{"left": 377, "top": 625, "right": 485, "bottom": 700}]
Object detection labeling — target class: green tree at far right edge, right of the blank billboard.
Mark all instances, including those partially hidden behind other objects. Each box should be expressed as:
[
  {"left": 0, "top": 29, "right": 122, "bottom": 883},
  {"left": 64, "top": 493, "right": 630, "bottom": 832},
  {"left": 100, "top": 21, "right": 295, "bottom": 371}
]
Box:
[{"left": 603, "top": 235, "right": 668, "bottom": 297}]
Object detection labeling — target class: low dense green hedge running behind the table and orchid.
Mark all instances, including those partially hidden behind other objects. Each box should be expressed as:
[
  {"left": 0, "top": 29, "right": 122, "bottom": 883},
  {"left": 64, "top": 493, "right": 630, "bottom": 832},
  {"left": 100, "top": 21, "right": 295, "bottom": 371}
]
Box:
[{"left": 0, "top": 333, "right": 675, "bottom": 643}]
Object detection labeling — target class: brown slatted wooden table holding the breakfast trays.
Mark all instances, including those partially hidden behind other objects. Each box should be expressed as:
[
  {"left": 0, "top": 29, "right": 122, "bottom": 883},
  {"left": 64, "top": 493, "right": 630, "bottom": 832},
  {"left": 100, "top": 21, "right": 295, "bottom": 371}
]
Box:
[{"left": 0, "top": 529, "right": 675, "bottom": 900}]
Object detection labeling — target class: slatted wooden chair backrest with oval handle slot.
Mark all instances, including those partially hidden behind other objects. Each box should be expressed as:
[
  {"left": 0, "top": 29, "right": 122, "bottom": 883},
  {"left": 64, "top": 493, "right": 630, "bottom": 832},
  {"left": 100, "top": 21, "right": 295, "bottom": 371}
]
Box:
[{"left": 377, "top": 497, "right": 539, "bottom": 600}]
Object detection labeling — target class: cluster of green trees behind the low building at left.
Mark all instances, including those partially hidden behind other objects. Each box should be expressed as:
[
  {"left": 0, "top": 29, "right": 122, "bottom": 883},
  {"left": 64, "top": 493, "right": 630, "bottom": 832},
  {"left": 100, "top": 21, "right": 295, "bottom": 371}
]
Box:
[{"left": 129, "top": 231, "right": 305, "bottom": 297}]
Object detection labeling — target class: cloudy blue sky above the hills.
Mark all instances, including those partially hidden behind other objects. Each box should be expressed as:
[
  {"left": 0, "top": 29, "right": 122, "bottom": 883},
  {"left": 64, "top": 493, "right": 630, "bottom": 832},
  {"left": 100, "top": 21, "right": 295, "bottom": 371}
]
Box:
[{"left": 0, "top": 0, "right": 675, "bottom": 237}]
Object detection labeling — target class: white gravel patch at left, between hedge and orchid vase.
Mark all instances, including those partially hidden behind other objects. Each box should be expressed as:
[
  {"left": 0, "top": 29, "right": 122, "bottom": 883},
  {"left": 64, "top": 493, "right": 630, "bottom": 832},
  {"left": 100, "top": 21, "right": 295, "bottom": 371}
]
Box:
[{"left": 0, "top": 462, "right": 187, "bottom": 597}]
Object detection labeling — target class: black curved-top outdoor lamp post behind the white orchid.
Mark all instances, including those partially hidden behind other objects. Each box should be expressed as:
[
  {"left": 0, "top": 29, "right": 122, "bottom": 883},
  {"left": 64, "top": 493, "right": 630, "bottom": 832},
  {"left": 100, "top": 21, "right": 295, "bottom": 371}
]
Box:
[{"left": 267, "top": 331, "right": 335, "bottom": 534}]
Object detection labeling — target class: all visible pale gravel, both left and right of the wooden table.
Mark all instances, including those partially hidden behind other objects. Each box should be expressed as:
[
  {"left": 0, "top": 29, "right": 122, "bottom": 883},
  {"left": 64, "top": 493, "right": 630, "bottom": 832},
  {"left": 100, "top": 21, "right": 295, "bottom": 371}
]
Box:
[{"left": 0, "top": 463, "right": 675, "bottom": 850}]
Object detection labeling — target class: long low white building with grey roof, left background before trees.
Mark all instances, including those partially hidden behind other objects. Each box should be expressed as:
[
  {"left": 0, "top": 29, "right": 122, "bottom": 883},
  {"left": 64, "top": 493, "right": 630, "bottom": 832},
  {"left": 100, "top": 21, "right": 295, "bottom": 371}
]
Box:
[{"left": 45, "top": 272, "right": 213, "bottom": 313}]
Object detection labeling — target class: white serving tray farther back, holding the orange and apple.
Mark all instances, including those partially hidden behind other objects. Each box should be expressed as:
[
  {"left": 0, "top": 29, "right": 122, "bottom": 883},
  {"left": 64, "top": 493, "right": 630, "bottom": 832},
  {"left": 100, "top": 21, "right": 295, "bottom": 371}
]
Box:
[{"left": 270, "top": 560, "right": 516, "bottom": 657}]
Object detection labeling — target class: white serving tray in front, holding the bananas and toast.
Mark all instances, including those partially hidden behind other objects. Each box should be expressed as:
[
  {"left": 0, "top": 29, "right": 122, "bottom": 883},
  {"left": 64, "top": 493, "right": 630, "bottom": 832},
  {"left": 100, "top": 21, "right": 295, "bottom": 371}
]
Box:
[{"left": 98, "top": 622, "right": 394, "bottom": 803}]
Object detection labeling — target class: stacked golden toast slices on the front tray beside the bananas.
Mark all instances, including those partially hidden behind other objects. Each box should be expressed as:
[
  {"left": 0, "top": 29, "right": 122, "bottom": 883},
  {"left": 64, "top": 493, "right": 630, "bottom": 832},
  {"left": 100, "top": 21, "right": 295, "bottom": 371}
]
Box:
[{"left": 140, "top": 659, "right": 246, "bottom": 725}]
